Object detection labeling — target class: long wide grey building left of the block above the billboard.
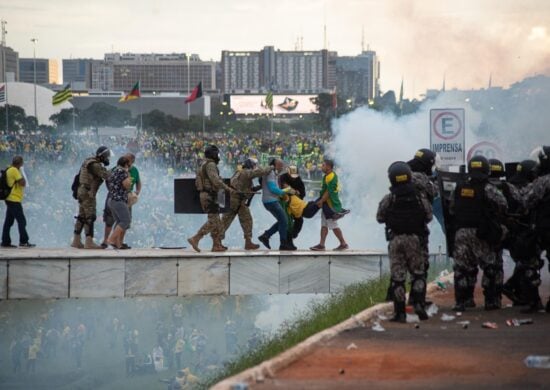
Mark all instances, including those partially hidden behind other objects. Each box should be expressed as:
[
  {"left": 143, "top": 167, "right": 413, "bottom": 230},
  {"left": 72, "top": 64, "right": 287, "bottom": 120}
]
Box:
[{"left": 91, "top": 53, "right": 217, "bottom": 93}]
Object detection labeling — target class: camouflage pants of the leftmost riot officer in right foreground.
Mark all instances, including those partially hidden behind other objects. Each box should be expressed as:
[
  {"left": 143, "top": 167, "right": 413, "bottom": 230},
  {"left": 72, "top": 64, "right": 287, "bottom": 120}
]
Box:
[{"left": 388, "top": 234, "right": 426, "bottom": 302}]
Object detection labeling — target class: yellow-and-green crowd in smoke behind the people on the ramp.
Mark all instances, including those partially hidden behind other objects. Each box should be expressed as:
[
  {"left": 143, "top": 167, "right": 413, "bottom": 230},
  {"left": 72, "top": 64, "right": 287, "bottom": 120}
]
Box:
[{"left": 0, "top": 129, "right": 329, "bottom": 247}]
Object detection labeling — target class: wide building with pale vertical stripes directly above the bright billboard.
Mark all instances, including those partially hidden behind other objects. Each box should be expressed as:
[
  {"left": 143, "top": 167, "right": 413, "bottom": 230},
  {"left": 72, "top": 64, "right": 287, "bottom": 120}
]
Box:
[{"left": 222, "top": 46, "right": 337, "bottom": 94}]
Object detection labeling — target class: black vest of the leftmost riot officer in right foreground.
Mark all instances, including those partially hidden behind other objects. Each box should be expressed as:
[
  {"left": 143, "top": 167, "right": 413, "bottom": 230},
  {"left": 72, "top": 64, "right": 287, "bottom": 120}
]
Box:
[{"left": 386, "top": 190, "right": 428, "bottom": 236}]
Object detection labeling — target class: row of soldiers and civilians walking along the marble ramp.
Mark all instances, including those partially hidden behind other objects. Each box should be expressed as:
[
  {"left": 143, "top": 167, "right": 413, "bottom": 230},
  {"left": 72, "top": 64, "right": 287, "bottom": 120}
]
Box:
[{"left": 0, "top": 145, "right": 349, "bottom": 252}]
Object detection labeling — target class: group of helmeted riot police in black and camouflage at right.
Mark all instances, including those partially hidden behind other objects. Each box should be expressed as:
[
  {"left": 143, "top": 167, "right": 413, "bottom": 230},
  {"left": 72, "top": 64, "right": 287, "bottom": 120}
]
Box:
[{"left": 377, "top": 146, "right": 550, "bottom": 323}]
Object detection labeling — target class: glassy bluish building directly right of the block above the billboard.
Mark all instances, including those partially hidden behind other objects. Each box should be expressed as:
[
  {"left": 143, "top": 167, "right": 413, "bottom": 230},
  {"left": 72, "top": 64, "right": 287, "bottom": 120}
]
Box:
[{"left": 336, "top": 50, "right": 380, "bottom": 103}]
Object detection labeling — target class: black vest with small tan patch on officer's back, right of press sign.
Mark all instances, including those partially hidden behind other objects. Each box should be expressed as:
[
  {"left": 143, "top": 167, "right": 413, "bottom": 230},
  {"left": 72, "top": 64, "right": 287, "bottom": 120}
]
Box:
[{"left": 454, "top": 183, "right": 487, "bottom": 229}]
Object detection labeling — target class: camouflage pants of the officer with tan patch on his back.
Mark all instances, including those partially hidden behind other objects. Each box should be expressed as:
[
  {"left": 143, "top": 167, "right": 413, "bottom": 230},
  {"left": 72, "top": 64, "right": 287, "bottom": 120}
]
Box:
[{"left": 453, "top": 228, "right": 503, "bottom": 302}]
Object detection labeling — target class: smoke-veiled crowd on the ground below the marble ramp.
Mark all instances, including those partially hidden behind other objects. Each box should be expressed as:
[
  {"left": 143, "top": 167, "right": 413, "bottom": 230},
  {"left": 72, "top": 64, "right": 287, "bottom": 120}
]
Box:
[{"left": 0, "top": 297, "right": 270, "bottom": 384}]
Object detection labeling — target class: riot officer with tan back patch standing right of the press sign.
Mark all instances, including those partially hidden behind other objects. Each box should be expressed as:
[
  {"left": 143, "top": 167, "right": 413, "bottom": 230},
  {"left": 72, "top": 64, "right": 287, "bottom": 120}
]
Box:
[{"left": 450, "top": 156, "right": 508, "bottom": 311}]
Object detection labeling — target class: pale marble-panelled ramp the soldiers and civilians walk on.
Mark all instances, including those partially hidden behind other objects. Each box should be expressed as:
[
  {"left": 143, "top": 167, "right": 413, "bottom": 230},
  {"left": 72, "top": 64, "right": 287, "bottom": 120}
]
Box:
[{"left": 0, "top": 248, "right": 388, "bottom": 299}]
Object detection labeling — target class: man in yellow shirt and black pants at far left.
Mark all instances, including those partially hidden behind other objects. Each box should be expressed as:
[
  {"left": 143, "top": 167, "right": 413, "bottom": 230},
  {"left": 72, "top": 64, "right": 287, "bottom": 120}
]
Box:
[{"left": 0, "top": 156, "right": 35, "bottom": 248}]
